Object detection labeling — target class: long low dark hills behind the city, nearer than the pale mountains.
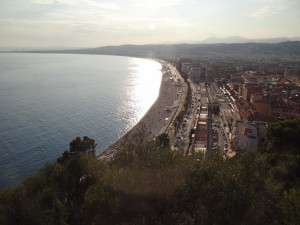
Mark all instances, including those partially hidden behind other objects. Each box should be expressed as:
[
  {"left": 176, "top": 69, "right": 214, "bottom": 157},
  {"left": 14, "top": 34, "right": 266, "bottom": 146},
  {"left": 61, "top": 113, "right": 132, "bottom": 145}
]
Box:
[{"left": 23, "top": 41, "right": 300, "bottom": 61}]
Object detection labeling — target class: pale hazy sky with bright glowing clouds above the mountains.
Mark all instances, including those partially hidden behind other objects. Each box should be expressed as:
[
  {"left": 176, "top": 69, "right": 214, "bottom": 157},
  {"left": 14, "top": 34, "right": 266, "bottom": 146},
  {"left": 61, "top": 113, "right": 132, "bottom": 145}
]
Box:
[{"left": 0, "top": 0, "right": 300, "bottom": 49}]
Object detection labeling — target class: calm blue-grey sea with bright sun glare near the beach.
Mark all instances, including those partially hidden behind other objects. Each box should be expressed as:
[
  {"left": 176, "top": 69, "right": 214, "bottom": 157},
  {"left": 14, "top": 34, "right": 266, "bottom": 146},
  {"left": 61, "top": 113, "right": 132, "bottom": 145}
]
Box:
[{"left": 0, "top": 53, "right": 161, "bottom": 187}]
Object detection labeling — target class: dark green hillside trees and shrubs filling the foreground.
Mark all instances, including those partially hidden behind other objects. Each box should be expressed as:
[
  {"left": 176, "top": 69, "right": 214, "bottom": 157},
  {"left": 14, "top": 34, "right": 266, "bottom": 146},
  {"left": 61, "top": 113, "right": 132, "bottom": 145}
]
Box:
[{"left": 0, "top": 120, "right": 300, "bottom": 225}]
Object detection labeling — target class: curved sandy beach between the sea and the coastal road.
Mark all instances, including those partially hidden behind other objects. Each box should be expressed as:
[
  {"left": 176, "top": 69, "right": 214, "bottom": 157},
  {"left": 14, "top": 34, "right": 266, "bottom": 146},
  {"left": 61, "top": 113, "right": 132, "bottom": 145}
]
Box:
[{"left": 97, "top": 60, "right": 186, "bottom": 159}]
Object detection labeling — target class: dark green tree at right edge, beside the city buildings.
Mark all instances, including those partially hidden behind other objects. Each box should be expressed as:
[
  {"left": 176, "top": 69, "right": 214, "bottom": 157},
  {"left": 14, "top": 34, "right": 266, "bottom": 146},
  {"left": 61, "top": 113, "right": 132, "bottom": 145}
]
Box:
[{"left": 267, "top": 119, "right": 300, "bottom": 194}]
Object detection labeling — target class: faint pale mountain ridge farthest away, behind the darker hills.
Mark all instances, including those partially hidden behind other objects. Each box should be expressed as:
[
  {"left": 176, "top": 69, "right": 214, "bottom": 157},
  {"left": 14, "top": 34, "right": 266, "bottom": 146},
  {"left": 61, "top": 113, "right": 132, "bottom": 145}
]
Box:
[{"left": 164, "top": 36, "right": 300, "bottom": 44}]
